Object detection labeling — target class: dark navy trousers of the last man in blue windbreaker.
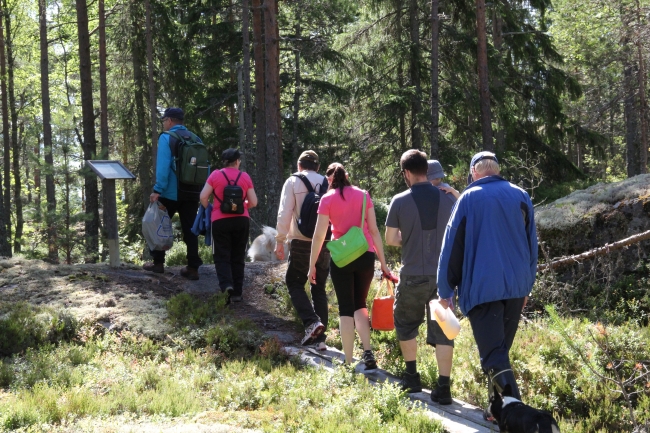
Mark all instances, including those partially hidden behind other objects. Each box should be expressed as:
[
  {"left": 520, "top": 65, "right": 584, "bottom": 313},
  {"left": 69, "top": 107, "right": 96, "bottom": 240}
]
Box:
[{"left": 467, "top": 298, "right": 524, "bottom": 373}]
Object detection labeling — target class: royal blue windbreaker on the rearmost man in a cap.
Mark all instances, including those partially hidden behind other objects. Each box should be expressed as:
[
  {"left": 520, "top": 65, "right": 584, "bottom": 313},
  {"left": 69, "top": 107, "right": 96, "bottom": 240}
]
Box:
[{"left": 438, "top": 176, "right": 537, "bottom": 315}]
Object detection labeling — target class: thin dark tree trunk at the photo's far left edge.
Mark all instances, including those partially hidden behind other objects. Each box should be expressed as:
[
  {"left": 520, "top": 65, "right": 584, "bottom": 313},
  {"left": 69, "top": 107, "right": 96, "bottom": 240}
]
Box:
[{"left": 0, "top": 2, "right": 11, "bottom": 257}]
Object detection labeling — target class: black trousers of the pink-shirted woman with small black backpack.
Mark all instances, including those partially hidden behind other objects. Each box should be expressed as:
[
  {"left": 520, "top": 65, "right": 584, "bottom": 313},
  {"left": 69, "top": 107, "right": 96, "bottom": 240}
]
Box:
[{"left": 212, "top": 217, "right": 250, "bottom": 296}]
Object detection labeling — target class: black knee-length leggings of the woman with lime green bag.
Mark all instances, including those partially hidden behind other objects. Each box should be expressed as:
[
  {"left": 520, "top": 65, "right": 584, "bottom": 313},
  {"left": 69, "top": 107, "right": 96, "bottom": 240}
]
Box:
[{"left": 330, "top": 251, "right": 375, "bottom": 317}]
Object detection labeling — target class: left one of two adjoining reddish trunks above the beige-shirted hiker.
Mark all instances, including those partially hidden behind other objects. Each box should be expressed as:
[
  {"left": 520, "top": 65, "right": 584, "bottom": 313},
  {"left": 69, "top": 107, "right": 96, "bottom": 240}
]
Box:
[{"left": 252, "top": 0, "right": 266, "bottom": 230}]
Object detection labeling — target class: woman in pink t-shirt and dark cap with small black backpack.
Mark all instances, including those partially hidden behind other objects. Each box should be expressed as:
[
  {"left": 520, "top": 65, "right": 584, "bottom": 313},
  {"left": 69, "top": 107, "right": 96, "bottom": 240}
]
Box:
[{"left": 200, "top": 149, "right": 257, "bottom": 302}]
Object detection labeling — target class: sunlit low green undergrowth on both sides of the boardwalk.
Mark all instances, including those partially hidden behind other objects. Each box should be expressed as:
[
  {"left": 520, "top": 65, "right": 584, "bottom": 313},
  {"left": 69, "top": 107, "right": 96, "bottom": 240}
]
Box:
[{"left": 0, "top": 251, "right": 650, "bottom": 432}]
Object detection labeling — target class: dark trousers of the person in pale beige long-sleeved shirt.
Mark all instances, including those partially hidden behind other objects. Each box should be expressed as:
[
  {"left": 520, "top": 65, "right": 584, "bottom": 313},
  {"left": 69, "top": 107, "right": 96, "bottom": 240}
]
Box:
[{"left": 285, "top": 239, "right": 330, "bottom": 343}]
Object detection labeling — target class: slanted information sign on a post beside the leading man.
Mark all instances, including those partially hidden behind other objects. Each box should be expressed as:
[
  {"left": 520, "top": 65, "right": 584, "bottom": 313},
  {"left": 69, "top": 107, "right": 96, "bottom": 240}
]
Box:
[{"left": 86, "top": 161, "right": 135, "bottom": 268}]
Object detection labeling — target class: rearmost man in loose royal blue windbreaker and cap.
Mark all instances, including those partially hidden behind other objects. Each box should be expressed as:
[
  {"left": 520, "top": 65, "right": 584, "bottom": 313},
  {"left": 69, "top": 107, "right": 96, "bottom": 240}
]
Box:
[{"left": 438, "top": 152, "right": 537, "bottom": 419}]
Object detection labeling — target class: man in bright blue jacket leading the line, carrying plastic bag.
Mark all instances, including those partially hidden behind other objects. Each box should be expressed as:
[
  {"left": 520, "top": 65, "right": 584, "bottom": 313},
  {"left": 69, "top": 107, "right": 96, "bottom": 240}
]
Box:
[{"left": 143, "top": 107, "right": 203, "bottom": 280}]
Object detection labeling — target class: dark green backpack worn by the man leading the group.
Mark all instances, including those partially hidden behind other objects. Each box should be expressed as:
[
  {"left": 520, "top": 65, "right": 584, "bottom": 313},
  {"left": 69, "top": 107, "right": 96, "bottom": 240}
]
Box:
[{"left": 163, "top": 130, "right": 210, "bottom": 200}]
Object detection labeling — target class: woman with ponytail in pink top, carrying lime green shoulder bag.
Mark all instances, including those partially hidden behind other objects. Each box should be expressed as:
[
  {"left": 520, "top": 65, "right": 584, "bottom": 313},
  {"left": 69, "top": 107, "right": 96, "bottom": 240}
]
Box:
[{"left": 309, "top": 162, "right": 390, "bottom": 372}]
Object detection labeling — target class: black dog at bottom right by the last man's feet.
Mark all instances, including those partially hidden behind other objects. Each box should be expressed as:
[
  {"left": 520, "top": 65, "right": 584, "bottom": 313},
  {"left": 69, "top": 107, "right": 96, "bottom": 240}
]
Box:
[{"left": 490, "top": 385, "right": 560, "bottom": 433}]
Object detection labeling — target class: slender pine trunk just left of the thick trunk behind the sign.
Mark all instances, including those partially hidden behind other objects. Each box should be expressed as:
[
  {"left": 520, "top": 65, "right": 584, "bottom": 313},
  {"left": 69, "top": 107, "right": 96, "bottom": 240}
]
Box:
[{"left": 38, "top": 0, "right": 57, "bottom": 263}]
